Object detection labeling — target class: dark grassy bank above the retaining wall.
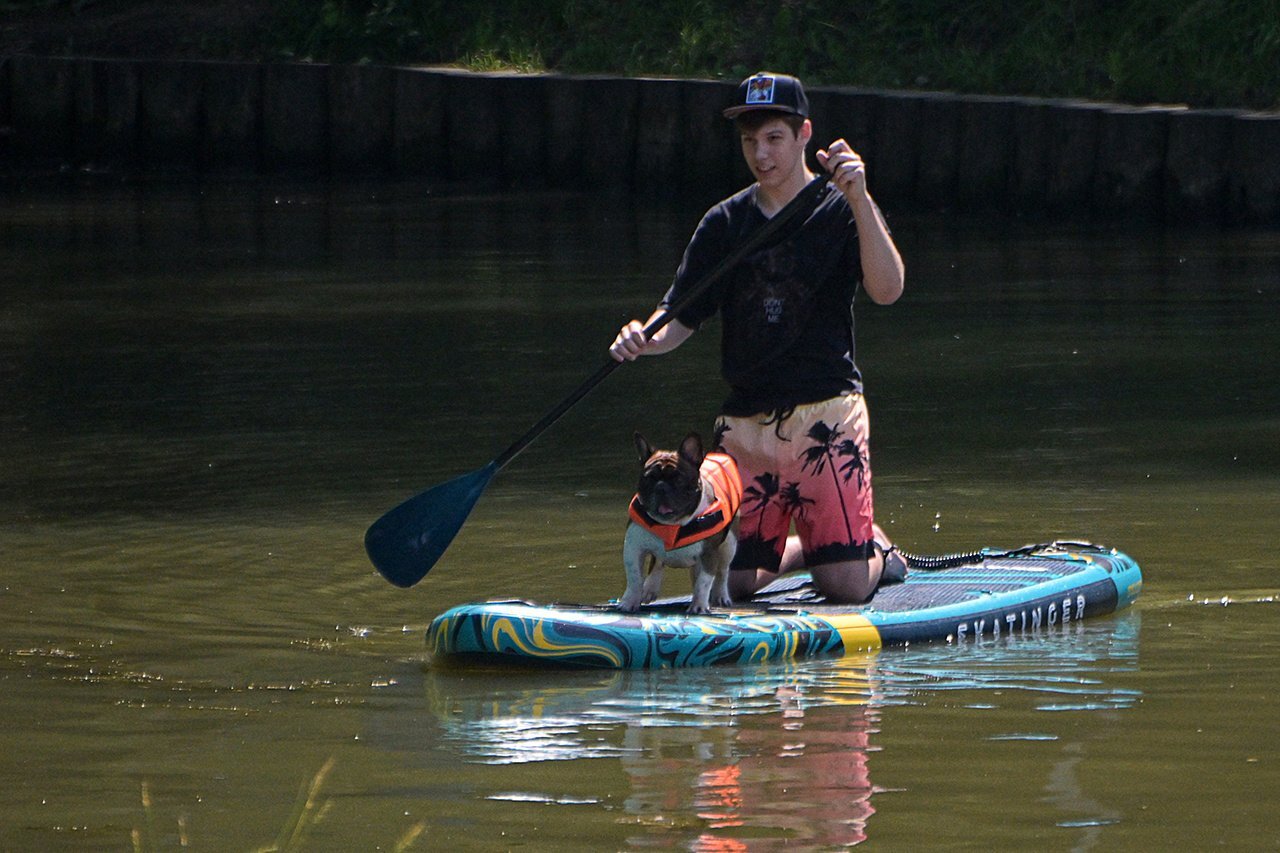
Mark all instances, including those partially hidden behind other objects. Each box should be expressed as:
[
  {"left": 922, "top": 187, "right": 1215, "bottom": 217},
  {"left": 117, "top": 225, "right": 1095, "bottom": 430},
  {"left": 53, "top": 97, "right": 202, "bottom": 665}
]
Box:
[{"left": 0, "top": 0, "right": 1280, "bottom": 110}]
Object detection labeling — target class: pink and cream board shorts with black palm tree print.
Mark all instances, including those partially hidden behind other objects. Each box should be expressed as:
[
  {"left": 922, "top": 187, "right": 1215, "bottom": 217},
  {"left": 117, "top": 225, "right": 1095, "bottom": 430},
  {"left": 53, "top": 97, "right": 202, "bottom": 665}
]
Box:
[{"left": 716, "top": 394, "right": 874, "bottom": 571}]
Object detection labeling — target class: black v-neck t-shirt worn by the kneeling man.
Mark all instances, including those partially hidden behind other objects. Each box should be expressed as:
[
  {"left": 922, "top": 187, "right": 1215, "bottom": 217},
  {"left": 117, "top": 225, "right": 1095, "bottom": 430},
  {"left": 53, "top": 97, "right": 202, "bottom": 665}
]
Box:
[{"left": 662, "top": 184, "right": 863, "bottom": 416}]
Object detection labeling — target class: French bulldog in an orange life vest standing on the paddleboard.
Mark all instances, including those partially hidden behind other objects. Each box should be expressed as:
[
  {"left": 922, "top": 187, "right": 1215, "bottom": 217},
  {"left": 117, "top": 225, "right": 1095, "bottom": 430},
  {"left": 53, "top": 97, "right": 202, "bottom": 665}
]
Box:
[{"left": 618, "top": 433, "right": 742, "bottom": 613}]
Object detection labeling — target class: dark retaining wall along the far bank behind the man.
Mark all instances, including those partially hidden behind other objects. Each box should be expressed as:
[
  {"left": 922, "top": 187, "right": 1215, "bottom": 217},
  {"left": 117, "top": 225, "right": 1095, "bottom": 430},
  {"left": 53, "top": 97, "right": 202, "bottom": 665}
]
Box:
[{"left": 0, "top": 56, "right": 1280, "bottom": 223}]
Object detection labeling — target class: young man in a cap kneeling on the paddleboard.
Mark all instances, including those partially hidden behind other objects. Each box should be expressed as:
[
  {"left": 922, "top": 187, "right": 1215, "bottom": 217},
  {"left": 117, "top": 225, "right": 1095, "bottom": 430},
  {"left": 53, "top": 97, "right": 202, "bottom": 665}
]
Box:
[{"left": 609, "top": 72, "right": 904, "bottom": 602}]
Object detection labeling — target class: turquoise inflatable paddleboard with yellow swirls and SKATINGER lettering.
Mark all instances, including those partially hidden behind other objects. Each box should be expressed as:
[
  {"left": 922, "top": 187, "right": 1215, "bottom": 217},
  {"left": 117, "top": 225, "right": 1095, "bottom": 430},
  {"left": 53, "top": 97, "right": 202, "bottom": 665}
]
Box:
[{"left": 426, "top": 542, "right": 1142, "bottom": 669}]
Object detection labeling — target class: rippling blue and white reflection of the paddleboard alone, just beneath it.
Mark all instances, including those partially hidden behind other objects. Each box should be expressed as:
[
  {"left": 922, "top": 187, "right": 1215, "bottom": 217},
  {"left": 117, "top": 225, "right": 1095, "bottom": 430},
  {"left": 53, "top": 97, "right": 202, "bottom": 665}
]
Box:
[{"left": 426, "top": 611, "right": 1140, "bottom": 763}]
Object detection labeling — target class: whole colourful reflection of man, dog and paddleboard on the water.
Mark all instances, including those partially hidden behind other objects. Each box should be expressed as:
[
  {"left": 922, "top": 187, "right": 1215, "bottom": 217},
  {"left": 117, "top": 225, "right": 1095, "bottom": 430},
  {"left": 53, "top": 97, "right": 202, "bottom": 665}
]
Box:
[{"left": 407, "top": 612, "right": 1142, "bottom": 850}]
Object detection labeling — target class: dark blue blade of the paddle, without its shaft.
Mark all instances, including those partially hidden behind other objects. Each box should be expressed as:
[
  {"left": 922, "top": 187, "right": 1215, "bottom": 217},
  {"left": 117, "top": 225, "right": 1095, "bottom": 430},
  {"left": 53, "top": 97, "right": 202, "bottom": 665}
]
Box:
[{"left": 365, "top": 462, "right": 498, "bottom": 587}]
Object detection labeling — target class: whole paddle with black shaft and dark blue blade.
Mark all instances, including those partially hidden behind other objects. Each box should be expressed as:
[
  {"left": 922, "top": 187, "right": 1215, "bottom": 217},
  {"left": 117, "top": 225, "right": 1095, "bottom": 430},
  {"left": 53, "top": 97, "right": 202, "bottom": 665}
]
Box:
[{"left": 365, "top": 173, "right": 828, "bottom": 587}]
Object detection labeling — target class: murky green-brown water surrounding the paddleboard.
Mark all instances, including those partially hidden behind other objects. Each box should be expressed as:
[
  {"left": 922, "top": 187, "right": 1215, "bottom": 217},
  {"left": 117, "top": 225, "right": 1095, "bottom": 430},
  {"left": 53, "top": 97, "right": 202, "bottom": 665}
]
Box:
[{"left": 0, "top": 183, "right": 1280, "bottom": 850}]
